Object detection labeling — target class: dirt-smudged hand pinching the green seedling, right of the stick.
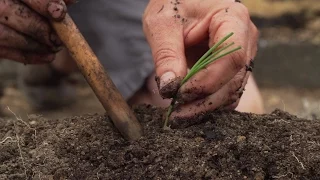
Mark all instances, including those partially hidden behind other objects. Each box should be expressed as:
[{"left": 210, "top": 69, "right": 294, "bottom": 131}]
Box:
[{"left": 143, "top": 0, "right": 259, "bottom": 118}]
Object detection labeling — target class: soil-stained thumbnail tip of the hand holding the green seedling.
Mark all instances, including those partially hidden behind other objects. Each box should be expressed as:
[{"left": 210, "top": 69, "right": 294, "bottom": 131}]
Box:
[{"left": 158, "top": 71, "right": 182, "bottom": 98}]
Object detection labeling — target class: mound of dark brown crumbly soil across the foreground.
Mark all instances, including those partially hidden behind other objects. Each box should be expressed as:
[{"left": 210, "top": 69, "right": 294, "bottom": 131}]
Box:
[{"left": 0, "top": 106, "right": 320, "bottom": 180}]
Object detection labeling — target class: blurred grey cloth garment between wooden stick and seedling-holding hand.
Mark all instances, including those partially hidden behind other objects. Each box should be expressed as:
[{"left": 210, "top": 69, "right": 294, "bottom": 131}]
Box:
[{"left": 69, "top": 0, "right": 154, "bottom": 99}]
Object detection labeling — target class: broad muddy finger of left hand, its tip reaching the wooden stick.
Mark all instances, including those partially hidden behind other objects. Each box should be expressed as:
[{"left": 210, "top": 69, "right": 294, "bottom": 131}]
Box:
[{"left": 0, "top": 0, "right": 62, "bottom": 51}]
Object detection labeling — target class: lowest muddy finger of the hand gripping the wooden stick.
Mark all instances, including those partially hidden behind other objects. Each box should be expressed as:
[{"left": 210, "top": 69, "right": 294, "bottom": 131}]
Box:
[{"left": 0, "top": 46, "right": 55, "bottom": 64}]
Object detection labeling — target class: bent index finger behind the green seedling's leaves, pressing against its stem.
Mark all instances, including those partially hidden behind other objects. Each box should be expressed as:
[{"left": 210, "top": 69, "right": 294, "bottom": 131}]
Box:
[{"left": 179, "top": 4, "right": 251, "bottom": 102}]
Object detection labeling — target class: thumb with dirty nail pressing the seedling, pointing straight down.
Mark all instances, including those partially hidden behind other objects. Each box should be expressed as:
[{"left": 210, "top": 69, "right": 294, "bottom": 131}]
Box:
[{"left": 143, "top": 11, "right": 187, "bottom": 98}]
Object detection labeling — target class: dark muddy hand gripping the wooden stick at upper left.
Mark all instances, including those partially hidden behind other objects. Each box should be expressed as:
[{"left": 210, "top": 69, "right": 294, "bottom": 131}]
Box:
[{"left": 0, "top": 0, "right": 70, "bottom": 64}]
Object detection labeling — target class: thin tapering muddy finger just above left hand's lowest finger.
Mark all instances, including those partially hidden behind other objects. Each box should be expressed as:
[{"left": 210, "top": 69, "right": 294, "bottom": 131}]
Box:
[{"left": 0, "top": 23, "right": 49, "bottom": 53}]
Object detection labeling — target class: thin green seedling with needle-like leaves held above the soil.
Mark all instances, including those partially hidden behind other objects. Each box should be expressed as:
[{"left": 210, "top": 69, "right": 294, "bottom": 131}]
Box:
[{"left": 163, "top": 33, "right": 241, "bottom": 129}]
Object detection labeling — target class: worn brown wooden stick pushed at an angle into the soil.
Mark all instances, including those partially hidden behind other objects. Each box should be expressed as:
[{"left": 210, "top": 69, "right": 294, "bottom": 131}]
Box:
[{"left": 52, "top": 14, "right": 142, "bottom": 140}]
